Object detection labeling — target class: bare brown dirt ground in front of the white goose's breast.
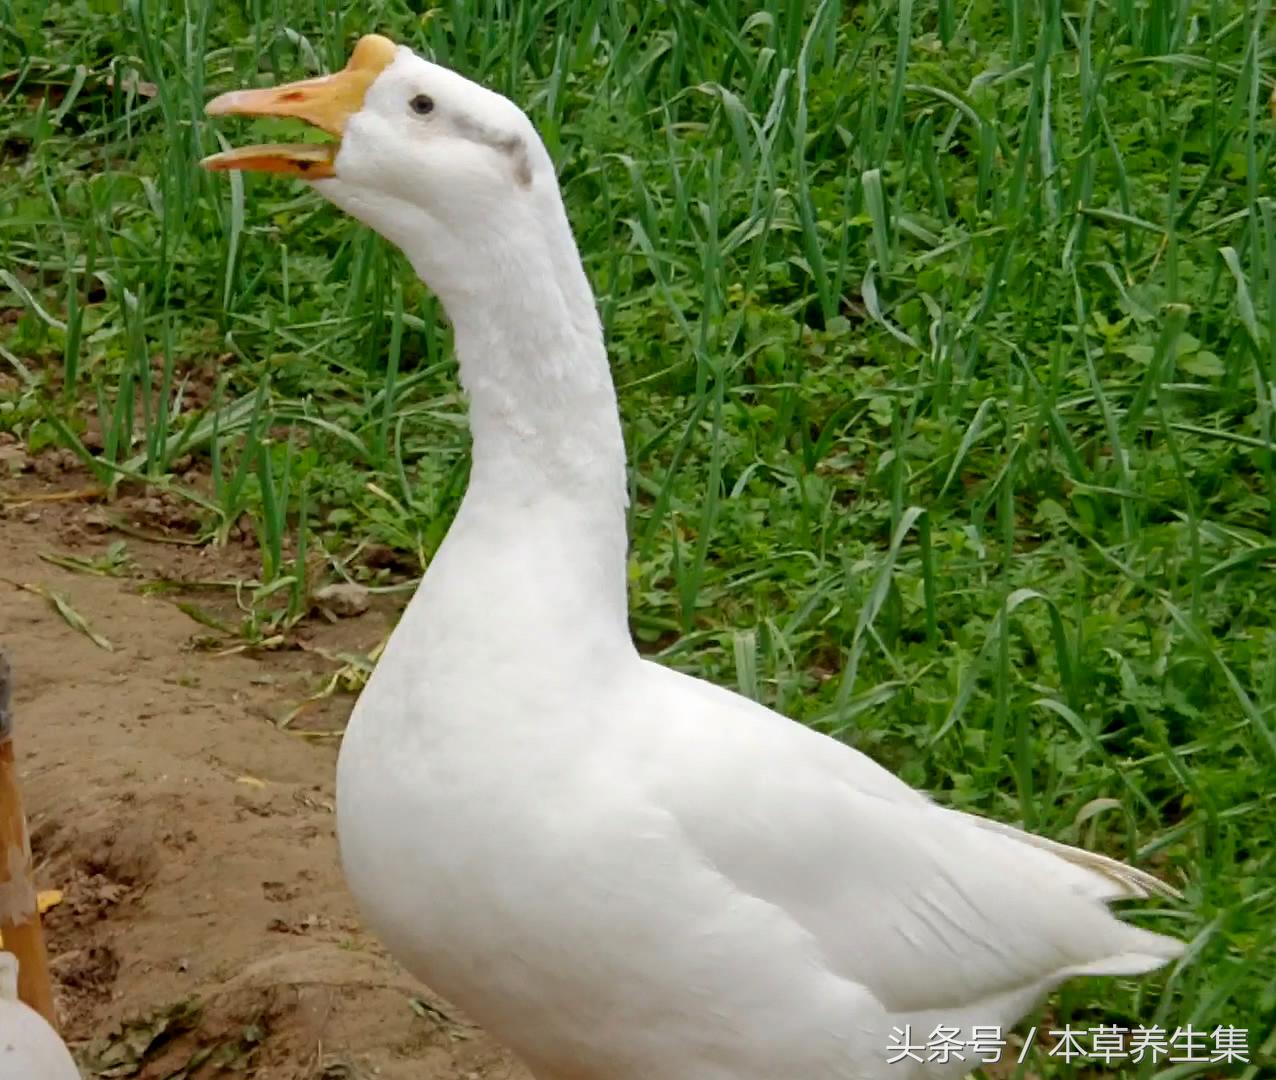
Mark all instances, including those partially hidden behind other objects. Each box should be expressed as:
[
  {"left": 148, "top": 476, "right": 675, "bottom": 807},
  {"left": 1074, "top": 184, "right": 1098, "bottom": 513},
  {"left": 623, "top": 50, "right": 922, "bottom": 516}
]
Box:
[{"left": 0, "top": 462, "right": 527, "bottom": 1080}]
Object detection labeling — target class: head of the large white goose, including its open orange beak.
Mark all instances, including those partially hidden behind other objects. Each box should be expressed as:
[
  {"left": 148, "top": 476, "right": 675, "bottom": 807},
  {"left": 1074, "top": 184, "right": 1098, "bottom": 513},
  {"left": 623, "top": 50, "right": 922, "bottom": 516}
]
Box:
[{"left": 202, "top": 34, "right": 565, "bottom": 299}]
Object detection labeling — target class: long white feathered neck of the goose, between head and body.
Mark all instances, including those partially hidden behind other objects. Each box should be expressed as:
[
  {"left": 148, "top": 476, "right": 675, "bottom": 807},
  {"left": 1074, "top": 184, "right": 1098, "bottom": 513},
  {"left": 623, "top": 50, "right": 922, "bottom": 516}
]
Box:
[{"left": 334, "top": 185, "right": 632, "bottom": 649}]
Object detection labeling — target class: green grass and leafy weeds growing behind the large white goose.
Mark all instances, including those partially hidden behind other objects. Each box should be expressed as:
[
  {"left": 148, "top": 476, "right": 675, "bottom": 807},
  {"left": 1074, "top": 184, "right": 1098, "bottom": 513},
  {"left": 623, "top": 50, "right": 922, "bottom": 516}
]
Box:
[{"left": 0, "top": 0, "right": 1276, "bottom": 1080}]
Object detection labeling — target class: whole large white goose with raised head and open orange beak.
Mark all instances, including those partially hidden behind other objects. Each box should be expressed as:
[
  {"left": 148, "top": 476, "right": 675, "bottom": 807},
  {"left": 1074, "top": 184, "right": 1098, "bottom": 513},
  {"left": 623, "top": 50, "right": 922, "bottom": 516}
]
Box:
[{"left": 204, "top": 36, "right": 1183, "bottom": 1080}]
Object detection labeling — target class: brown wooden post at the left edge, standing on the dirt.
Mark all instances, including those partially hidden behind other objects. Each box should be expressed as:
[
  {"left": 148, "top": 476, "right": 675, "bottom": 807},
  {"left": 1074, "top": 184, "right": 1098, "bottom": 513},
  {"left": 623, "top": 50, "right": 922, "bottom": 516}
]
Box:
[{"left": 0, "top": 652, "right": 57, "bottom": 1030}]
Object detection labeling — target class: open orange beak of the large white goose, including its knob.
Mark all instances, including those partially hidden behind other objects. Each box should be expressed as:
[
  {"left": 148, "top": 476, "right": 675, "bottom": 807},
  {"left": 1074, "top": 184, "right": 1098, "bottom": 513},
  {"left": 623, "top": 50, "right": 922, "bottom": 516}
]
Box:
[{"left": 200, "top": 33, "right": 396, "bottom": 180}]
